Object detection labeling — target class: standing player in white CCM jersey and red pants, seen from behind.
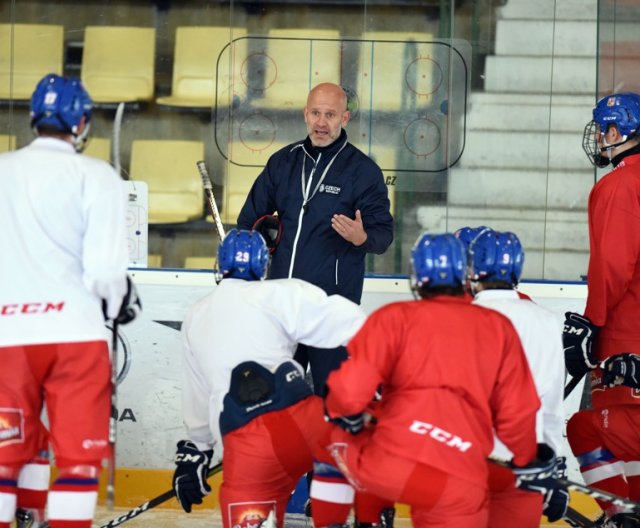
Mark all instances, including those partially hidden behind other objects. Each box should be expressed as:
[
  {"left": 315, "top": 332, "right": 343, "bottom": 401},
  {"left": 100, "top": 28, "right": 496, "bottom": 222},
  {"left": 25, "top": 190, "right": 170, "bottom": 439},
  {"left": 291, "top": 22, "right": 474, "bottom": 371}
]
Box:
[{"left": 0, "top": 74, "right": 139, "bottom": 528}]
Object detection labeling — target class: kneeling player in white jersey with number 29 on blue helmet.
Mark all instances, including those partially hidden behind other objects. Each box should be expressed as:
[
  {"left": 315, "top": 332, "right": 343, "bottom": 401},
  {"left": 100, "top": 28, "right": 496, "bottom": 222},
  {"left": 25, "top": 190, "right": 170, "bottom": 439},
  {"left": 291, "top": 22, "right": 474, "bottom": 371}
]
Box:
[{"left": 173, "top": 229, "right": 365, "bottom": 528}]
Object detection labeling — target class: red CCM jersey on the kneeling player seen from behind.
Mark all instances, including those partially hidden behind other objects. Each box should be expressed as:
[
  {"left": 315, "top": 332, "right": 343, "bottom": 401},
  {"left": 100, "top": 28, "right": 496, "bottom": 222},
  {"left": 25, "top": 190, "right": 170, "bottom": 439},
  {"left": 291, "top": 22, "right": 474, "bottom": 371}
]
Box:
[{"left": 326, "top": 296, "right": 540, "bottom": 486}]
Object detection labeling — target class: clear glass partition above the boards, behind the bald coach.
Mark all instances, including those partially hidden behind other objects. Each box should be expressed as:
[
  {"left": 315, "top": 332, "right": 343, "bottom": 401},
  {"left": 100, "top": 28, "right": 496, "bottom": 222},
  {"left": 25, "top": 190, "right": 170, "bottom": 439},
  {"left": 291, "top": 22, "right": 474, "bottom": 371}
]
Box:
[{"left": 0, "top": 0, "right": 604, "bottom": 281}]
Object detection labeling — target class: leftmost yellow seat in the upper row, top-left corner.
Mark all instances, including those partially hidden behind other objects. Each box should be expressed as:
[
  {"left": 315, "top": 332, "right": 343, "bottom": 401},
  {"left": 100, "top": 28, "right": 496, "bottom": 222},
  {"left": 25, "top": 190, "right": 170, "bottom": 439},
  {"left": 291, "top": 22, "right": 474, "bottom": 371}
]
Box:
[{"left": 0, "top": 24, "right": 64, "bottom": 100}]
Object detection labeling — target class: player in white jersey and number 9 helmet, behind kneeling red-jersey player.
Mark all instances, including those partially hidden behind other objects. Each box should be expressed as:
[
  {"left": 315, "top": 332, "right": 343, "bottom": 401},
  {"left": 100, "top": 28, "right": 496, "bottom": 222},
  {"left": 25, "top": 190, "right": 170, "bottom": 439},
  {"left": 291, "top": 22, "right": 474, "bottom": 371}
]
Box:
[{"left": 468, "top": 227, "right": 569, "bottom": 528}]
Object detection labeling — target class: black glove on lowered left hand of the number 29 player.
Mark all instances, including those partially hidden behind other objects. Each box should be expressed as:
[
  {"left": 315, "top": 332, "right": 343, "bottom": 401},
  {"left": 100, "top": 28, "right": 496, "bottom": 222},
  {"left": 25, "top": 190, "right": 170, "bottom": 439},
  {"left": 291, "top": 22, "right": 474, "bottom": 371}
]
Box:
[{"left": 173, "top": 440, "right": 213, "bottom": 513}]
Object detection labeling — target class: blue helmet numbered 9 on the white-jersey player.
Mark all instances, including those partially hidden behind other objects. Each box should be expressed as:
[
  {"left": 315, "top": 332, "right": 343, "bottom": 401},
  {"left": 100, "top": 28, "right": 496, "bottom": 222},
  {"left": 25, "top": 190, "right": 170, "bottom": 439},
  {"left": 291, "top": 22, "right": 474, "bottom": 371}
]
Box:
[{"left": 469, "top": 230, "right": 524, "bottom": 286}]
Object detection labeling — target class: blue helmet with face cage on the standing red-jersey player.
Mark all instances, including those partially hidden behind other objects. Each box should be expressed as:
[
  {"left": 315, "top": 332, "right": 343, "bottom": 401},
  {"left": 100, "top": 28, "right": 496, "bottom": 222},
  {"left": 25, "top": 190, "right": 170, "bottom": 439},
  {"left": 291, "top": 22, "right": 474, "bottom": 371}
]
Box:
[{"left": 582, "top": 92, "right": 640, "bottom": 167}]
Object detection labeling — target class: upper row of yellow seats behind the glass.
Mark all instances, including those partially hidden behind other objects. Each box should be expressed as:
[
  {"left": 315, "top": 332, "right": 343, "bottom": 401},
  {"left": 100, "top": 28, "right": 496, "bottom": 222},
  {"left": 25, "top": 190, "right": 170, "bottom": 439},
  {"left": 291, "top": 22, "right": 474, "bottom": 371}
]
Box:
[{"left": 0, "top": 24, "right": 441, "bottom": 110}]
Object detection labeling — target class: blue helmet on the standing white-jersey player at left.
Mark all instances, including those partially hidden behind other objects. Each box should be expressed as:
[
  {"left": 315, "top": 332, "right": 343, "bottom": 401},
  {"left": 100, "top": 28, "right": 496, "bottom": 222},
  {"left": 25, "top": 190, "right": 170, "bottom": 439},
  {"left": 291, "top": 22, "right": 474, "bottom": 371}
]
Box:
[{"left": 30, "top": 73, "right": 93, "bottom": 136}]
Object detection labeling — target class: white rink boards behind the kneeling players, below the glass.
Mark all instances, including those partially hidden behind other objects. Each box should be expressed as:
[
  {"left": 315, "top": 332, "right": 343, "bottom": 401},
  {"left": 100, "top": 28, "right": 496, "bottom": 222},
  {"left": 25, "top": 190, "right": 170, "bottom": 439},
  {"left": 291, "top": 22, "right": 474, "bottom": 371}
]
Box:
[{"left": 117, "top": 269, "right": 586, "bottom": 480}]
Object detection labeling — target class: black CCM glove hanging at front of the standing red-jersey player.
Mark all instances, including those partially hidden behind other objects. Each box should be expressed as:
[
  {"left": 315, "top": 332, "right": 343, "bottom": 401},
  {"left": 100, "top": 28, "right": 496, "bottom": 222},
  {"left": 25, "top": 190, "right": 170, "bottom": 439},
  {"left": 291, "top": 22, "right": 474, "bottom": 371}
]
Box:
[{"left": 562, "top": 312, "right": 600, "bottom": 378}]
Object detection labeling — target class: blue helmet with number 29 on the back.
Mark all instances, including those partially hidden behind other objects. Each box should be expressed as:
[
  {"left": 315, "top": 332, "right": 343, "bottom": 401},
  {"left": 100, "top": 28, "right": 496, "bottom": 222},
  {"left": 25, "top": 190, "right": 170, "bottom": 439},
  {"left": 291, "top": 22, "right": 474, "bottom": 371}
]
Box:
[{"left": 218, "top": 229, "right": 269, "bottom": 280}]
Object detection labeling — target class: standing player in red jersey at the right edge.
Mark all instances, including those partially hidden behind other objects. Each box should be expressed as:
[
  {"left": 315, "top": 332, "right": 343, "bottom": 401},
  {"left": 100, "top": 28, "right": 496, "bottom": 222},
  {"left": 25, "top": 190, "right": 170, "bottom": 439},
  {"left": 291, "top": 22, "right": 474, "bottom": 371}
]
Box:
[{"left": 563, "top": 93, "right": 640, "bottom": 527}]
